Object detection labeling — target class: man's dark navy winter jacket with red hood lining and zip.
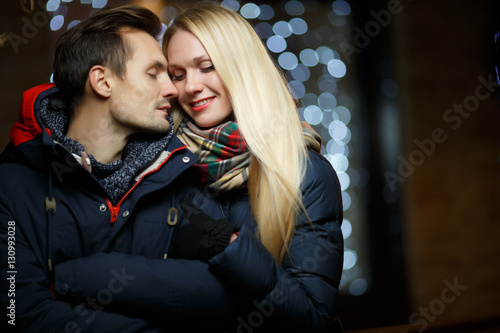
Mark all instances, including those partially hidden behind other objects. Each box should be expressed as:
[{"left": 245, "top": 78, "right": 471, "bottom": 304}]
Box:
[{"left": 0, "top": 84, "right": 234, "bottom": 333}]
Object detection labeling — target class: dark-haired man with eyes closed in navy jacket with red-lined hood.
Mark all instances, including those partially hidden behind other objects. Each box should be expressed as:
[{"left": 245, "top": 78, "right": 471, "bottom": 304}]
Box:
[{"left": 0, "top": 6, "right": 232, "bottom": 332}]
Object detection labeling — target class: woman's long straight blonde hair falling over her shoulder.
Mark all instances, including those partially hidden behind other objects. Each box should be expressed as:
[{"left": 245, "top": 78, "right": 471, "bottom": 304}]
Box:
[{"left": 163, "top": 5, "right": 307, "bottom": 263}]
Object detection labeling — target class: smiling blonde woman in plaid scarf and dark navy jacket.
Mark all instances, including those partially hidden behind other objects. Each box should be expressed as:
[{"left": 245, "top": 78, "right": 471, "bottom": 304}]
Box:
[{"left": 164, "top": 5, "right": 343, "bottom": 332}]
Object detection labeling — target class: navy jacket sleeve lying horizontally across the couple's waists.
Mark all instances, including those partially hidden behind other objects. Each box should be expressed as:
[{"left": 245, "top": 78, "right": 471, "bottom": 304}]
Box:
[{"left": 55, "top": 252, "right": 235, "bottom": 326}]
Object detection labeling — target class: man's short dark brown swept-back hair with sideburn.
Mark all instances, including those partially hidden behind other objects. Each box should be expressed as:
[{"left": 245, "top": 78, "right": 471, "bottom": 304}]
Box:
[{"left": 53, "top": 5, "right": 162, "bottom": 109}]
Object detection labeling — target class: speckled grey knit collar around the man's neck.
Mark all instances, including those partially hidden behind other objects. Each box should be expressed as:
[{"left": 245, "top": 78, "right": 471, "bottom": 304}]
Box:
[{"left": 40, "top": 98, "right": 174, "bottom": 204}]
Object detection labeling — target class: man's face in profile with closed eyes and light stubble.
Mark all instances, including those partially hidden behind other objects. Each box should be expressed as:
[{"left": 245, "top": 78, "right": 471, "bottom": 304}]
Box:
[{"left": 110, "top": 30, "right": 177, "bottom": 135}]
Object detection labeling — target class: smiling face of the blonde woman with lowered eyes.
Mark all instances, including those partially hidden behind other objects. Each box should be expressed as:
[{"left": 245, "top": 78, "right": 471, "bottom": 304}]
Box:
[{"left": 167, "top": 29, "right": 233, "bottom": 128}]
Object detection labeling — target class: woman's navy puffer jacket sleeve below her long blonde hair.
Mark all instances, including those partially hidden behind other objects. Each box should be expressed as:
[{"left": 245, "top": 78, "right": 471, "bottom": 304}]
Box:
[{"left": 210, "top": 155, "right": 343, "bottom": 332}]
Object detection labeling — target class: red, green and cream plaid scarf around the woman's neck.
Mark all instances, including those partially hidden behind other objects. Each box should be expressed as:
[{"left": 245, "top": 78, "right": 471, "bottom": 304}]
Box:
[{"left": 177, "top": 117, "right": 321, "bottom": 193}]
